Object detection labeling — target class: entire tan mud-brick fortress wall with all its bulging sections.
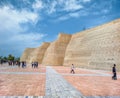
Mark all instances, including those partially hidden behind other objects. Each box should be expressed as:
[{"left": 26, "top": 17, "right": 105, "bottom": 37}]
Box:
[{"left": 21, "top": 19, "right": 120, "bottom": 71}]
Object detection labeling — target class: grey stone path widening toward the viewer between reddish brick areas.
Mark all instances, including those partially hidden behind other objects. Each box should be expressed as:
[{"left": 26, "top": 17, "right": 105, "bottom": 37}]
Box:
[{"left": 46, "top": 67, "right": 85, "bottom": 98}]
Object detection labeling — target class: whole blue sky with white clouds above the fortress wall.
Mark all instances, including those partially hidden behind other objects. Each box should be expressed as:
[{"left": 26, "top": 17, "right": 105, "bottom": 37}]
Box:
[{"left": 0, "top": 0, "right": 120, "bottom": 56}]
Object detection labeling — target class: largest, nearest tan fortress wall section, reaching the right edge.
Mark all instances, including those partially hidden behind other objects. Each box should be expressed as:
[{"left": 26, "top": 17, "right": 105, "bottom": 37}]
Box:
[{"left": 63, "top": 19, "right": 120, "bottom": 70}]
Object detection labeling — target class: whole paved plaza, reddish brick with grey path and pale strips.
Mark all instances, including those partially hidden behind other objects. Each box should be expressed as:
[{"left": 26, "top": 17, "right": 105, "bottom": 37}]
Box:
[{"left": 0, "top": 64, "right": 120, "bottom": 98}]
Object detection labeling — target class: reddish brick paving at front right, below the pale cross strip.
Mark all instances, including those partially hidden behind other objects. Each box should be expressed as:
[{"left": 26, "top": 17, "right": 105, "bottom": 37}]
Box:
[{"left": 64, "top": 76, "right": 120, "bottom": 96}]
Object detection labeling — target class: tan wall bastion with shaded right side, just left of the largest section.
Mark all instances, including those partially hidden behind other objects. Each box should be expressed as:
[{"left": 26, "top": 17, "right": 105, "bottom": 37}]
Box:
[{"left": 42, "top": 33, "right": 71, "bottom": 65}]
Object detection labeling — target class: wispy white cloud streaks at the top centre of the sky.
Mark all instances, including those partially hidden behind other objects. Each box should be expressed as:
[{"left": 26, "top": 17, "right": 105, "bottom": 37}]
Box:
[{"left": 44, "top": 0, "right": 84, "bottom": 14}]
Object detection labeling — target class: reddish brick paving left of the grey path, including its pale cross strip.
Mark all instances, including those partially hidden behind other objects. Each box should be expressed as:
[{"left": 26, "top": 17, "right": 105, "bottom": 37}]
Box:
[{"left": 0, "top": 65, "right": 45, "bottom": 96}]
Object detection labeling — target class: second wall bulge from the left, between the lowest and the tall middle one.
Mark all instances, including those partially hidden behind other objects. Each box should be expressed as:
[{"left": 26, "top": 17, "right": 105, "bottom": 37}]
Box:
[{"left": 29, "top": 42, "right": 50, "bottom": 64}]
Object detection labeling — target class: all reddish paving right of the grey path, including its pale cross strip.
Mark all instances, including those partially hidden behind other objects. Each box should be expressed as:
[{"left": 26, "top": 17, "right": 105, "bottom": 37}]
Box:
[{"left": 54, "top": 67, "right": 120, "bottom": 98}]
